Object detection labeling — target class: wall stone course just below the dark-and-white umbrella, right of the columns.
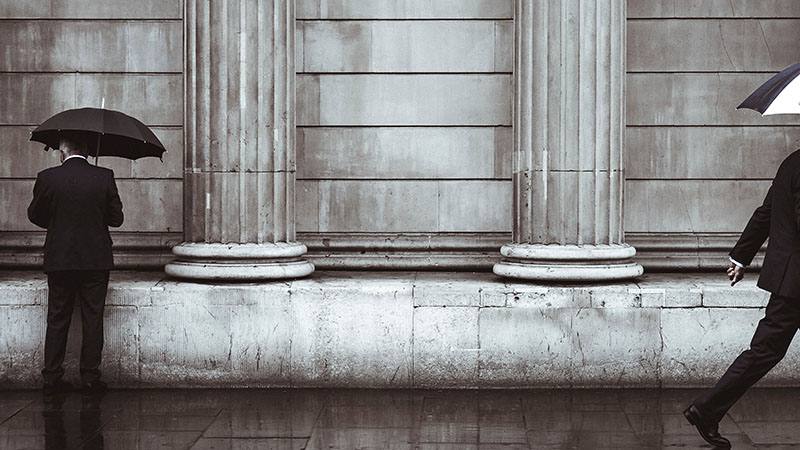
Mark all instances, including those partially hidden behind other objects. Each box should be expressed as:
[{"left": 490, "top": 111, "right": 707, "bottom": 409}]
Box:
[{"left": 625, "top": 126, "right": 800, "bottom": 179}]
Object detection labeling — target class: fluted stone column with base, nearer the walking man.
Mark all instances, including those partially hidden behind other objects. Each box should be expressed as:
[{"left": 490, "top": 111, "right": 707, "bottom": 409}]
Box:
[{"left": 494, "top": 0, "right": 643, "bottom": 281}]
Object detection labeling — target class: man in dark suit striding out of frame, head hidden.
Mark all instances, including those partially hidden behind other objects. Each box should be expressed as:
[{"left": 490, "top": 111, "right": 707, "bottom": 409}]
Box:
[{"left": 684, "top": 150, "right": 800, "bottom": 447}]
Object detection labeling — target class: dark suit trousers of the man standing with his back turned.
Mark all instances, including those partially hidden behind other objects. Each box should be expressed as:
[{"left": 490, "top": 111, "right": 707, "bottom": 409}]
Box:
[{"left": 42, "top": 270, "right": 108, "bottom": 383}]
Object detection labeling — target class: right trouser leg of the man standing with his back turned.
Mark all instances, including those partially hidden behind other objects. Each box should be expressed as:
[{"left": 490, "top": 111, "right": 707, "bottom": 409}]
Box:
[{"left": 78, "top": 270, "right": 108, "bottom": 384}]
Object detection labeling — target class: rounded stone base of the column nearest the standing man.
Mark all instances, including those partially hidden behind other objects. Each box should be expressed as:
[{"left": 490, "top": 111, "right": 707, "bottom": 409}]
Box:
[{"left": 164, "top": 242, "right": 314, "bottom": 281}]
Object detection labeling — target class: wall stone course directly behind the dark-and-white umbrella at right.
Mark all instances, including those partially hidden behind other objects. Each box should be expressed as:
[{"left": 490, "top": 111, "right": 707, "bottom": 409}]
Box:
[{"left": 625, "top": 73, "right": 800, "bottom": 126}]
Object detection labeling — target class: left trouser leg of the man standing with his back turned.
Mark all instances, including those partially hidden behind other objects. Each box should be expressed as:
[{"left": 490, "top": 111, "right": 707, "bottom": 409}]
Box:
[{"left": 42, "top": 272, "right": 76, "bottom": 384}]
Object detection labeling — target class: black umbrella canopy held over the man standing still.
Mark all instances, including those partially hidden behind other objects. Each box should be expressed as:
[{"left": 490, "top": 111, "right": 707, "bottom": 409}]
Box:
[{"left": 30, "top": 108, "right": 166, "bottom": 159}]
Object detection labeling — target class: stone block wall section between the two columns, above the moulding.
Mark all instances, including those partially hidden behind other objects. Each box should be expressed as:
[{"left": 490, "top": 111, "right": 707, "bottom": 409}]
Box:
[{"left": 297, "top": 0, "right": 513, "bottom": 239}]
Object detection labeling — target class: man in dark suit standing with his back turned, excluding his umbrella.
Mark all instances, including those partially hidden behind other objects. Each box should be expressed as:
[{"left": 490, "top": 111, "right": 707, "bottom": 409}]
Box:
[{"left": 28, "top": 133, "right": 123, "bottom": 394}]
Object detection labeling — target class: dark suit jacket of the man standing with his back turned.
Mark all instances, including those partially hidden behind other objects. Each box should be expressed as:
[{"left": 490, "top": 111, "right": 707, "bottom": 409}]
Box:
[{"left": 28, "top": 158, "right": 123, "bottom": 273}]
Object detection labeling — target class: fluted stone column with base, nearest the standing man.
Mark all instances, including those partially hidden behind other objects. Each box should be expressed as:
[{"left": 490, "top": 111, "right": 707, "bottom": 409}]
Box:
[{"left": 165, "top": 0, "right": 314, "bottom": 280}]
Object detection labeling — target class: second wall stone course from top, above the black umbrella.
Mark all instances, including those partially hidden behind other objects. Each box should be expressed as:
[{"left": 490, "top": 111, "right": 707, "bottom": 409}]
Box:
[{"left": 0, "top": 21, "right": 182, "bottom": 73}]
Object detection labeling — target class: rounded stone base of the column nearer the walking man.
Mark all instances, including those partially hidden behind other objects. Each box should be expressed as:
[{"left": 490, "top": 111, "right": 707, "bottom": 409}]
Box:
[{"left": 493, "top": 244, "right": 644, "bottom": 281}]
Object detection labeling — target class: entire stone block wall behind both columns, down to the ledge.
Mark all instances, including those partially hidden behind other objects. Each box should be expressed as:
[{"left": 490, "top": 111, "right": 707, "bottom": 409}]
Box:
[{"left": 0, "top": 0, "right": 800, "bottom": 270}]
